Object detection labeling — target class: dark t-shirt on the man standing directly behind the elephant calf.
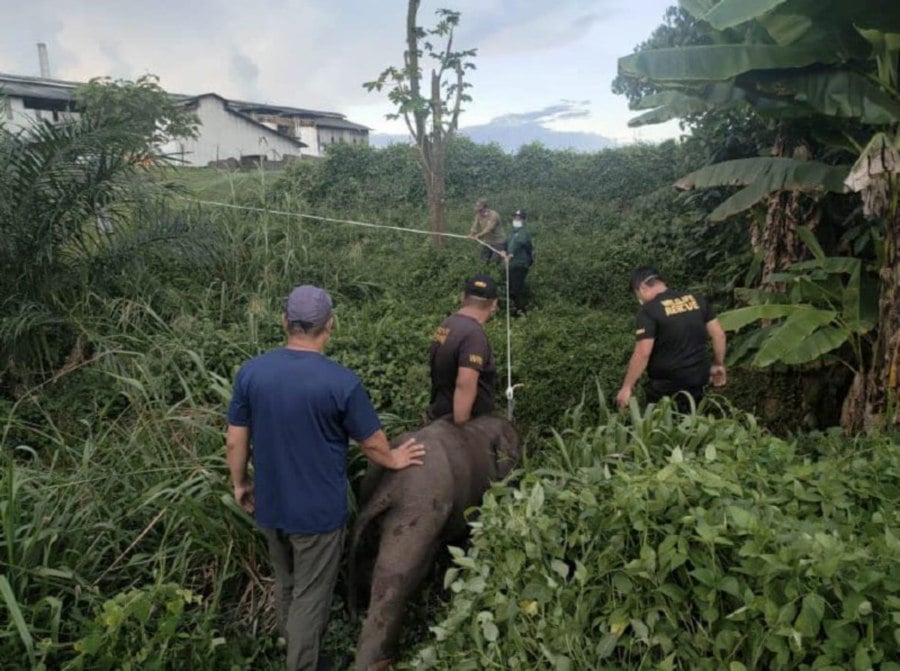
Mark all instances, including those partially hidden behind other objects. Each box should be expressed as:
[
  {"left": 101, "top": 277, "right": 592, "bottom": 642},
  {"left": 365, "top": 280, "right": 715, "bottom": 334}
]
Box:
[{"left": 428, "top": 313, "right": 497, "bottom": 418}]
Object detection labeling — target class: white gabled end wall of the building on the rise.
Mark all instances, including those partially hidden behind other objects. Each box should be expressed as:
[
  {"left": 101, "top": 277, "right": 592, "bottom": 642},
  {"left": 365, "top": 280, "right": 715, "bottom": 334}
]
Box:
[{"left": 163, "top": 96, "right": 300, "bottom": 166}]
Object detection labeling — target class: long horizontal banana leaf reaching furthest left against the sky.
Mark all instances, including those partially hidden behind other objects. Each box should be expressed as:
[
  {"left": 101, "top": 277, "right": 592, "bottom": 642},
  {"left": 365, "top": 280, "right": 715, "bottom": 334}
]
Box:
[{"left": 619, "top": 44, "right": 840, "bottom": 82}]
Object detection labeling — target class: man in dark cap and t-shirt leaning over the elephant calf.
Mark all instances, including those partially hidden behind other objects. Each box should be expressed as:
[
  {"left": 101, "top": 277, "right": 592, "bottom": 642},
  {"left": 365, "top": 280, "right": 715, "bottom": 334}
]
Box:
[{"left": 428, "top": 275, "right": 497, "bottom": 424}]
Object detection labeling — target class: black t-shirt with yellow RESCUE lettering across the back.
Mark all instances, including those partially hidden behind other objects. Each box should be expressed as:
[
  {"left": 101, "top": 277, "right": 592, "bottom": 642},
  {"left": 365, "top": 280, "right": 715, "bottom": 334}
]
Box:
[{"left": 635, "top": 289, "right": 716, "bottom": 387}]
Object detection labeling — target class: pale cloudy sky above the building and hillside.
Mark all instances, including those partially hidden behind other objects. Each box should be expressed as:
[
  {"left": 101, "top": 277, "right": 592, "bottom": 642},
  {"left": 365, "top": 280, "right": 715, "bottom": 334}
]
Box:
[{"left": 0, "top": 0, "right": 679, "bottom": 143}]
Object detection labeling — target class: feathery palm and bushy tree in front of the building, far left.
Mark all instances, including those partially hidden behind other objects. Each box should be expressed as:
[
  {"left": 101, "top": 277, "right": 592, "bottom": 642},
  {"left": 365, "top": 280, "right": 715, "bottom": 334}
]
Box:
[{"left": 0, "top": 78, "right": 206, "bottom": 383}]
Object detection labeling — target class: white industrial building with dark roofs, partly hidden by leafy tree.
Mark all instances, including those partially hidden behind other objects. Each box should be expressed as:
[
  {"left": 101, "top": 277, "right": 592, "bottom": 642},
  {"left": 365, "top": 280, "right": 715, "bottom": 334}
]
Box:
[{"left": 0, "top": 73, "right": 369, "bottom": 166}]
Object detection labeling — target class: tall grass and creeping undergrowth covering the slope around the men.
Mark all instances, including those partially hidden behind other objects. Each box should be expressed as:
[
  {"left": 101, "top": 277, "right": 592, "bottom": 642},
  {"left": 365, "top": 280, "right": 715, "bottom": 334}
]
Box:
[{"left": 0, "top": 124, "right": 828, "bottom": 669}]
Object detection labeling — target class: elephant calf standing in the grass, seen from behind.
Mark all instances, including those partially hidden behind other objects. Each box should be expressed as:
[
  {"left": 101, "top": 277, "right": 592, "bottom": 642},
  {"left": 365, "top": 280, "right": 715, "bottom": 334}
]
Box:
[{"left": 350, "top": 416, "right": 519, "bottom": 671}]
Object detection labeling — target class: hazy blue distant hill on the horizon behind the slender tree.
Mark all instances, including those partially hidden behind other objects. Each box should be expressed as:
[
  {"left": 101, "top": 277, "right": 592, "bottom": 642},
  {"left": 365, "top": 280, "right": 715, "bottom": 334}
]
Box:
[{"left": 369, "top": 117, "right": 616, "bottom": 153}]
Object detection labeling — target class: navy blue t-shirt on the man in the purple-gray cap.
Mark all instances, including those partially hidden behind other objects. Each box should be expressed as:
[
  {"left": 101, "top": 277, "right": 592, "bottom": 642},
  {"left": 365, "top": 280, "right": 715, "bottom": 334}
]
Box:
[{"left": 228, "top": 348, "right": 381, "bottom": 534}]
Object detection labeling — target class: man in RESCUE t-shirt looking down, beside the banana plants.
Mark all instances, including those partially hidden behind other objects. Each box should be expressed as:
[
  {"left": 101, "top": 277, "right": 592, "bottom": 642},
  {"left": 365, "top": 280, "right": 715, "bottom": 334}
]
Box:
[{"left": 616, "top": 266, "right": 726, "bottom": 412}]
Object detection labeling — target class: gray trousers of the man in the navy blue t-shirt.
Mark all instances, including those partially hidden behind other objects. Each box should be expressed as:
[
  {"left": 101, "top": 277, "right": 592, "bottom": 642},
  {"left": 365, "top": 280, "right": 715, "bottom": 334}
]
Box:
[{"left": 262, "top": 528, "right": 344, "bottom": 671}]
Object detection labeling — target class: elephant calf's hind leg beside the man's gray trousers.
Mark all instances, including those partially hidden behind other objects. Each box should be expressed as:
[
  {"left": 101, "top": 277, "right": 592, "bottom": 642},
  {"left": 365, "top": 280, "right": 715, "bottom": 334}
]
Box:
[{"left": 356, "top": 521, "right": 440, "bottom": 671}]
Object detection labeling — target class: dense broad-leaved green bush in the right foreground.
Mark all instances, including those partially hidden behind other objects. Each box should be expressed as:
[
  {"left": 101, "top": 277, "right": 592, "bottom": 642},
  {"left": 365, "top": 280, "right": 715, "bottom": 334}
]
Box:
[{"left": 405, "top": 401, "right": 900, "bottom": 669}]
